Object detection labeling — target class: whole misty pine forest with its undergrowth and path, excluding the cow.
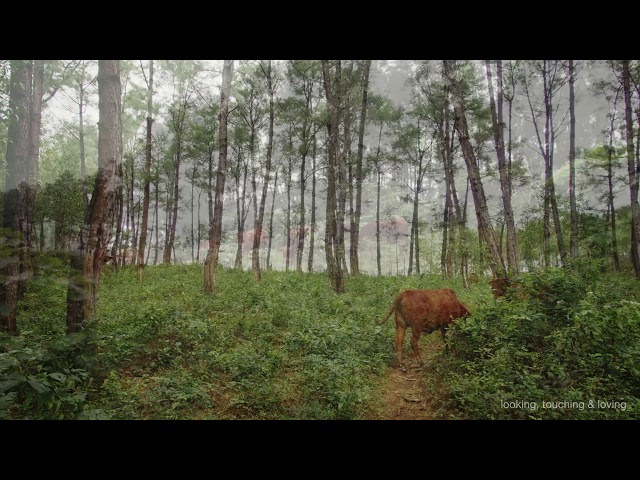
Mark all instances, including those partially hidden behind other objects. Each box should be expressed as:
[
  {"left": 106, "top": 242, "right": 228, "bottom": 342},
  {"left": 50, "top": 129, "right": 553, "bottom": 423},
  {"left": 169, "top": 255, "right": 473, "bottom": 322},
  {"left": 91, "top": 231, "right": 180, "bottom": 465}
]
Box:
[{"left": 0, "top": 60, "right": 640, "bottom": 420}]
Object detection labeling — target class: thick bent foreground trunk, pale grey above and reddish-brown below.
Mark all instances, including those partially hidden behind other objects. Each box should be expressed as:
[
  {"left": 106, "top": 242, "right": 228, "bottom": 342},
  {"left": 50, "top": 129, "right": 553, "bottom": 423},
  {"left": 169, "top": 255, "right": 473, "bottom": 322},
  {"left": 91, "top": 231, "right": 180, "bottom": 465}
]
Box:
[{"left": 67, "top": 60, "right": 122, "bottom": 333}]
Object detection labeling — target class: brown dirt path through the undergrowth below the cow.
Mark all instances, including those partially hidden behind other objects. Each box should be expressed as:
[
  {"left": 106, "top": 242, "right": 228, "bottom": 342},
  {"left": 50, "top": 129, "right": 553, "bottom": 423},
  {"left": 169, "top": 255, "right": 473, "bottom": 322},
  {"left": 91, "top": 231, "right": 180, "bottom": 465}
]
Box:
[{"left": 369, "top": 336, "right": 443, "bottom": 420}]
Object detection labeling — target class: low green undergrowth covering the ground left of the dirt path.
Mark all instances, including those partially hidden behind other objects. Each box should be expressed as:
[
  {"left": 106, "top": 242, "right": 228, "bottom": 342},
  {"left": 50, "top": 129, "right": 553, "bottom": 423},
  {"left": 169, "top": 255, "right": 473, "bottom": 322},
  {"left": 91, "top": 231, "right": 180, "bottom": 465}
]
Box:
[{"left": 0, "top": 265, "right": 480, "bottom": 419}]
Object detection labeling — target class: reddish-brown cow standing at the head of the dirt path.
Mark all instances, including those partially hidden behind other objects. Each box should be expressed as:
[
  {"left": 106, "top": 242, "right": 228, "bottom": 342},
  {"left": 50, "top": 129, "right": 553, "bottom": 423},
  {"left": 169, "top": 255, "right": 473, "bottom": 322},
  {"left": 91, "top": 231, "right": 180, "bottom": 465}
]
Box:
[{"left": 376, "top": 288, "right": 471, "bottom": 370}]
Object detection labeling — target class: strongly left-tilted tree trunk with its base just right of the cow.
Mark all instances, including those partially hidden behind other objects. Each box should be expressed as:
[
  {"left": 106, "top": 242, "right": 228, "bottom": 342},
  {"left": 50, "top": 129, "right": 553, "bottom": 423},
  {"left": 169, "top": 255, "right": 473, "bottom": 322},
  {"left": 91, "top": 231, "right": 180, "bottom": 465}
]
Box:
[{"left": 444, "top": 60, "right": 505, "bottom": 277}]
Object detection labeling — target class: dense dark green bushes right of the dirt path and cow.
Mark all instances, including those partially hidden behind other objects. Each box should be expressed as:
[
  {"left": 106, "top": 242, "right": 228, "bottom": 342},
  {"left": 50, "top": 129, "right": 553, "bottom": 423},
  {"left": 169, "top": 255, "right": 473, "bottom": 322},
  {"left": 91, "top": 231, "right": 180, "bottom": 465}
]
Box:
[{"left": 434, "top": 265, "right": 640, "bottom": 419}]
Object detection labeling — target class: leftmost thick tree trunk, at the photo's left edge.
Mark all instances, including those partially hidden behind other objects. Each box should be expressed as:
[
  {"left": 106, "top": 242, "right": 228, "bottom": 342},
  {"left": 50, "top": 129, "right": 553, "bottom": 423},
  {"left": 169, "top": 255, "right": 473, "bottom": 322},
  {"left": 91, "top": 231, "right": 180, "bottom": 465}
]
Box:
[{"left": 0, "top": 60, "right": 30, "bottom": 334}]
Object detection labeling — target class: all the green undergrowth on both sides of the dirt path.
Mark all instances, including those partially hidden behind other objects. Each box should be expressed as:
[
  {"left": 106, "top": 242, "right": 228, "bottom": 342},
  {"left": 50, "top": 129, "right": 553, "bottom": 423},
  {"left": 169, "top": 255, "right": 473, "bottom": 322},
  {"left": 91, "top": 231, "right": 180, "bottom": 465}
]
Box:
[{"left": 0, "top": 262, "right": 640, "bottom": 419}]
